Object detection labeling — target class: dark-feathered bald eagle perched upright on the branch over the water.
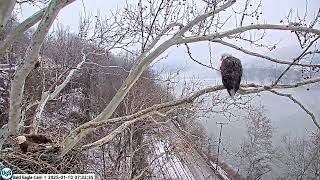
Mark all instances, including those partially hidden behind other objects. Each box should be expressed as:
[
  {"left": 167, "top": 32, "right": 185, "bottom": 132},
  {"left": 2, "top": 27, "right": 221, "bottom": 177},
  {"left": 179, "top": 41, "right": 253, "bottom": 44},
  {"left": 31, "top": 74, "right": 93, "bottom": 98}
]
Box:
[{"left": 220, "top": 54, "right": 242, "bottom": 98}]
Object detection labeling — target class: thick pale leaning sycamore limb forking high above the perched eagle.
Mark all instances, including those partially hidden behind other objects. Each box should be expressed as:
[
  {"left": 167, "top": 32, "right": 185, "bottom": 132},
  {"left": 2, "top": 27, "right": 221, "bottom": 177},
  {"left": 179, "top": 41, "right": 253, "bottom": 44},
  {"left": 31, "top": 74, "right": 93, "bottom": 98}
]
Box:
[{"left": 60, "top": 0, "right": 320, "bottom": 156}]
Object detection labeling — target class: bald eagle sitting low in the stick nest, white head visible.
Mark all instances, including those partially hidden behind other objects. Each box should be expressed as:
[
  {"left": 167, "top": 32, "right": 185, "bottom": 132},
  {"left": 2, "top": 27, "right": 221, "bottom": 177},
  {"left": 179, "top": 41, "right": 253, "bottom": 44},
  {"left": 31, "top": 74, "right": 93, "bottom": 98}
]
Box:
[{"left": 15, "top": 134, "right": 52, "bottom": 153}]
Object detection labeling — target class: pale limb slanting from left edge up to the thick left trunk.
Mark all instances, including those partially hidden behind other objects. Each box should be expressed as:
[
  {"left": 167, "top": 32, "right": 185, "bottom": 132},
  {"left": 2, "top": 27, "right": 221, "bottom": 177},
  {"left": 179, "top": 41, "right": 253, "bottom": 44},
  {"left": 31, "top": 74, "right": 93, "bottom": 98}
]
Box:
[{"left": 0, "top": 8, "right": 46, "bottom": 57}]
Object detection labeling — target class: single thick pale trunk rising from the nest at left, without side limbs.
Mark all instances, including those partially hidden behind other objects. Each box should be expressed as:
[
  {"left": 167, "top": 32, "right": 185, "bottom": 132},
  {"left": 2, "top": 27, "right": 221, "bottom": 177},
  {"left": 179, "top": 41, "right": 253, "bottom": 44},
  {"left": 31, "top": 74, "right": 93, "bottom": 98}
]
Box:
[{"left": 8, "top": 0, "right": 74, "bottom": 134}]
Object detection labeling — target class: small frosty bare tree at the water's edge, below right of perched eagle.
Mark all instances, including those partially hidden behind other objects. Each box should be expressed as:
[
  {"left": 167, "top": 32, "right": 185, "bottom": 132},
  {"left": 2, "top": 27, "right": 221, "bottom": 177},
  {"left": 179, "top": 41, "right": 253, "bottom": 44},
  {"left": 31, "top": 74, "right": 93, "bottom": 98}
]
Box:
[{"left": 239, "top": 107, "right": 274, "bottom": 179}]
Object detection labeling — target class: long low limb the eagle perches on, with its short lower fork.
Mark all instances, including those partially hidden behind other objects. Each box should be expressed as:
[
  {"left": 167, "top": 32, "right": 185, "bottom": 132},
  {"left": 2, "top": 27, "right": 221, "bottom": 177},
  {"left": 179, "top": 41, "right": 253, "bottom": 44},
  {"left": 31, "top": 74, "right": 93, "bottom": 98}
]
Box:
[{"left": 63, "top": 78, "right": 320, "bottom": 149}]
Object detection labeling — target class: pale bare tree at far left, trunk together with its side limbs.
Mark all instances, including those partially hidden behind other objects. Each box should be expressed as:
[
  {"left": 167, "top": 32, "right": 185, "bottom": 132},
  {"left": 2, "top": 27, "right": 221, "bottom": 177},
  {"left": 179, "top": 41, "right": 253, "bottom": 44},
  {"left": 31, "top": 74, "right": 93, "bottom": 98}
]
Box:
[{"left": 0, "top": 1, "right": 73, "bottom": 149}]
